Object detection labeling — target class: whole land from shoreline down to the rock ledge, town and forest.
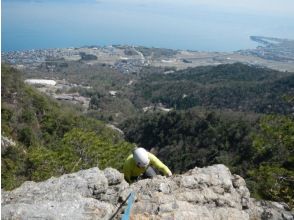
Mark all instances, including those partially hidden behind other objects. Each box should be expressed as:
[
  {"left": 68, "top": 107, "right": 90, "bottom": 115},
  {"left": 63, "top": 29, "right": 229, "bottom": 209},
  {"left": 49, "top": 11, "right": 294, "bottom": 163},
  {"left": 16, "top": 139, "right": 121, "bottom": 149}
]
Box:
[{"left": 1, "top": 37, "right": 294, "bottom": 207}]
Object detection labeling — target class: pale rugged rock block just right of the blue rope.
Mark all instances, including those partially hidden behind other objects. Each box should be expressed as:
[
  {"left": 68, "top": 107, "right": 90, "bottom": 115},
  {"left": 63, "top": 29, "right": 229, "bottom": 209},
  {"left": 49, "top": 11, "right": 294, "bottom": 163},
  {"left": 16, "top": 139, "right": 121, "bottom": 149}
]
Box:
[{"left": 131, "top": 165, "right": 249, "bottom": 219}]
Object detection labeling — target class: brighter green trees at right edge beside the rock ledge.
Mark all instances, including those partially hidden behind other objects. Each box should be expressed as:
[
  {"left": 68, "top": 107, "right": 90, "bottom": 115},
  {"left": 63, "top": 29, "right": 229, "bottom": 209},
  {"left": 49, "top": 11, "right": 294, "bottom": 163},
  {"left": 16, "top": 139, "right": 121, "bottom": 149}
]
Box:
[{"left": 248, "top": 115, "right": 294, "bottom": 207}]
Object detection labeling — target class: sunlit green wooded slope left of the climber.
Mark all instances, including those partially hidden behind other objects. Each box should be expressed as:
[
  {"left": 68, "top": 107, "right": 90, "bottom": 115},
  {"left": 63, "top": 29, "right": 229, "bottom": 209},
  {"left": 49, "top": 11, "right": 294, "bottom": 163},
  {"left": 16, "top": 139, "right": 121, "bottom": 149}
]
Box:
[{"left": 1, "top": 65, "right": 133, "bottom": 189}]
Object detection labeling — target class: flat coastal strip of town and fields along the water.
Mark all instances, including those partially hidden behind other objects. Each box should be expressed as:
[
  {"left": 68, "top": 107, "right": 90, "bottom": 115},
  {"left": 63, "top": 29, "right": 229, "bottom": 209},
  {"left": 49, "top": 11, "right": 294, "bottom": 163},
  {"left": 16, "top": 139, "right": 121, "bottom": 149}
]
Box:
[{"left": 1, "top": 36, "right": 294, "bottom": 73}]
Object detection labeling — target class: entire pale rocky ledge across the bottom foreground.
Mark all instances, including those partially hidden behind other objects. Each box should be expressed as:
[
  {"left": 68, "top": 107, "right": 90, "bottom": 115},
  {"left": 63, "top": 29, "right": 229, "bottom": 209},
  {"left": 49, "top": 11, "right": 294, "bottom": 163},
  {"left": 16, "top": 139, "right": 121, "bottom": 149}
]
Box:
[{"left": 1, "top": 165, "right": 294, "bottom": 220}]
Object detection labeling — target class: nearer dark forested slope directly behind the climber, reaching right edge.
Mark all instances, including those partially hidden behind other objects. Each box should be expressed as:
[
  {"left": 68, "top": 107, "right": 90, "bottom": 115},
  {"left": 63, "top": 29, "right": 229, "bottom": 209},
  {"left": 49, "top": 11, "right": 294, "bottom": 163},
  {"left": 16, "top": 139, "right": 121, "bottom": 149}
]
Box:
[{"left": 122, "top": 110, "right": 294, "bottom": 206}]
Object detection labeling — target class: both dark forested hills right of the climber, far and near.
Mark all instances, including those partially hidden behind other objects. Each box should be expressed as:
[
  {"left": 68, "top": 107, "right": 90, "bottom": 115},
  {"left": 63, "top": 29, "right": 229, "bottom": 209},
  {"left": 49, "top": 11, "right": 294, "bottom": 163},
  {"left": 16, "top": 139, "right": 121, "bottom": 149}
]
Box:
[{"left": 121, "top": 63, "right": 294, "bottom": 206}]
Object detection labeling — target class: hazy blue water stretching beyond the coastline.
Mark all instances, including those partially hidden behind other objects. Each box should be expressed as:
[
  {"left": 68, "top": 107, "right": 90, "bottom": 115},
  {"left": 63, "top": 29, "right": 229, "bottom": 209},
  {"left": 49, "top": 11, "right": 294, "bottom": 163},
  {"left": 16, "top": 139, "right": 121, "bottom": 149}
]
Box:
[{"left": 1, "top": 0, "right": 294, "bottom": 51}]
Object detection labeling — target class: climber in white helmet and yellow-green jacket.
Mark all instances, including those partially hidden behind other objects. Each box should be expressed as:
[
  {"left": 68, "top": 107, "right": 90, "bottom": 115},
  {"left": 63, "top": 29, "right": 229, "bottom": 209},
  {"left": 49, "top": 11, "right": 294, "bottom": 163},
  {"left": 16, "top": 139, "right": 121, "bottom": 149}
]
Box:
[{"left": 123, "top": 147, "right": 172, "bottom": 183}]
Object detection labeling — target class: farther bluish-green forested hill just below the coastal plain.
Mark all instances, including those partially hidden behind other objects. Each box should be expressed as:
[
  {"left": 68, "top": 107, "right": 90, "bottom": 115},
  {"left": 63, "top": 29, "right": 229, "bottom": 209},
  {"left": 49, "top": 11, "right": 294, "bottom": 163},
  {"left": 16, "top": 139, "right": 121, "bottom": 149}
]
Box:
[{"left": 134, "top": 63, "right": 294, "bottom": 114}]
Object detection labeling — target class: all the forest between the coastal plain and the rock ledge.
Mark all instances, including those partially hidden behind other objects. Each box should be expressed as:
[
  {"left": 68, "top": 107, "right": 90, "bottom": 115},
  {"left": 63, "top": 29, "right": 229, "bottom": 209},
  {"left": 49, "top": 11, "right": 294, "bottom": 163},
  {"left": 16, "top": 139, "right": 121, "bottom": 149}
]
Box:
[{"left": 1, "top": 62, "right": 294, "bottom": 207}]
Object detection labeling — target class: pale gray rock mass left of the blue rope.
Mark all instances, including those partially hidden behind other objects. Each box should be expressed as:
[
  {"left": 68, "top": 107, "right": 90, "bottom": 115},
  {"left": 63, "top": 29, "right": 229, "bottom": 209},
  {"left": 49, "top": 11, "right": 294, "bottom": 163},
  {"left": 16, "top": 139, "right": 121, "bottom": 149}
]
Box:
[{"left": 1, "top": 167, "right": 115, "bottom": 219}]
